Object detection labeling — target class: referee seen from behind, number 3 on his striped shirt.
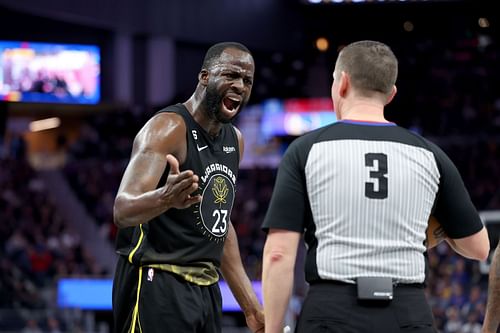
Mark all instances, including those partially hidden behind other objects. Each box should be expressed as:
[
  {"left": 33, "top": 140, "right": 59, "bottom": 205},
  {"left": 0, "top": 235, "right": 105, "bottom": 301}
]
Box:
[{"left": 262, "top": 41, "right": 489, "bottom": 333}]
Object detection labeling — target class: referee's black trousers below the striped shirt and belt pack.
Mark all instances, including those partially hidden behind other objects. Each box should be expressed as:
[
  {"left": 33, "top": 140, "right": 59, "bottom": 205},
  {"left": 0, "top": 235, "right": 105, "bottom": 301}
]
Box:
[{"left": 295, "top": 282, "right": 437, "bottom": 333}]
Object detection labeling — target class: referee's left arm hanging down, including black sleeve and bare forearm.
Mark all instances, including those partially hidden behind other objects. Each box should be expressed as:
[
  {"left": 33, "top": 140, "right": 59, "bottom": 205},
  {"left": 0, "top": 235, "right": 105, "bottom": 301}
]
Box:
[{"left": 262, "top": 137, "right": 309, "bottom": 333}]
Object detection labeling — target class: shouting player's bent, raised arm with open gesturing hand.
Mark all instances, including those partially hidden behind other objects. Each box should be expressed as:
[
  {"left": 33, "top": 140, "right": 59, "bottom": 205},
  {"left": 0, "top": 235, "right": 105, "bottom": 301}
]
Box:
[{"left": 113, "top": 113, "right": 200, "bottom": 228}]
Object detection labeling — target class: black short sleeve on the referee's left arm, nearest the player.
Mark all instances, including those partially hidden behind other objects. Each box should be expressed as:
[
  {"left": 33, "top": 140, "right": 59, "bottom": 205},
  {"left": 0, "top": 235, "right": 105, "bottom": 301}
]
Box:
[{"left": 262, "top": 139, "right": 309, "bottom": 233}]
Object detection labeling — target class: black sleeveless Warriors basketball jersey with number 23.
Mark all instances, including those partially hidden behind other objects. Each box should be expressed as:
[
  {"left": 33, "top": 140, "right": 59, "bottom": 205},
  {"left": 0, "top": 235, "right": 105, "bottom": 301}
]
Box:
[{"left": 116, "top": 104, "right": 240, "bottom": 271}]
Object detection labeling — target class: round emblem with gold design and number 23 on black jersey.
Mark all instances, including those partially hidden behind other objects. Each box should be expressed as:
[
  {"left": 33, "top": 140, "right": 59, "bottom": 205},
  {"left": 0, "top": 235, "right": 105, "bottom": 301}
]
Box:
[{"left": 200, "top": 174, "right": 234, "bottom": 240}]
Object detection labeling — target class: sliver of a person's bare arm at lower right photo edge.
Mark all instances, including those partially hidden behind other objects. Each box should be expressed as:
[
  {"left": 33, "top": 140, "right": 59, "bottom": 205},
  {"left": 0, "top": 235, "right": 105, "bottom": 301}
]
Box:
[{"left": 482, "top": 243, "right": 500, "bottom": 333}]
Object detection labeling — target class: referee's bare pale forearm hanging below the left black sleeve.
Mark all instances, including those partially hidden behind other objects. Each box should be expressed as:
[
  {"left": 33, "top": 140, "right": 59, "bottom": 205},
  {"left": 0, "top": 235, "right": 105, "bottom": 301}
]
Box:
[{"left": 262, "top": 229, "right": 301, "bottom": 333}]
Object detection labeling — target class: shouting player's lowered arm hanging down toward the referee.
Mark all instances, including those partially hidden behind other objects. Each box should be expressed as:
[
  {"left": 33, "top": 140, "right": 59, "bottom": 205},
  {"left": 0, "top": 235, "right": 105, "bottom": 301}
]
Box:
[{"left": 221, "top": 223, "right": 264, "bottom": 333}]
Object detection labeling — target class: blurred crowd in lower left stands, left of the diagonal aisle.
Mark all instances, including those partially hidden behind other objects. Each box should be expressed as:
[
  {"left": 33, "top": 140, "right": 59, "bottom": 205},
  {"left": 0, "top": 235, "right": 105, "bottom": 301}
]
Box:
[{"left": 0, "top": 154, "right": 103, "bottom": 333}]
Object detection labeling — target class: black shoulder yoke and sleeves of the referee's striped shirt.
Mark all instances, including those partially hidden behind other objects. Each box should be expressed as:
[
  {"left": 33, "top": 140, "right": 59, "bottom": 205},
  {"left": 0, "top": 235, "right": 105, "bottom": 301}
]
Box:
[{"left": 262, "top": 122, "right": 483, "bottom": 238}]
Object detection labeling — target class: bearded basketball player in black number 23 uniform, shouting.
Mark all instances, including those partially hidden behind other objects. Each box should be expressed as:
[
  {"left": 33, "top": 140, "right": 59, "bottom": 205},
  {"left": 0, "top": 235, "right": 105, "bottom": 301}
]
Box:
[{"left": 113, "top": 43, "right": 264, "bottom": 333}]
